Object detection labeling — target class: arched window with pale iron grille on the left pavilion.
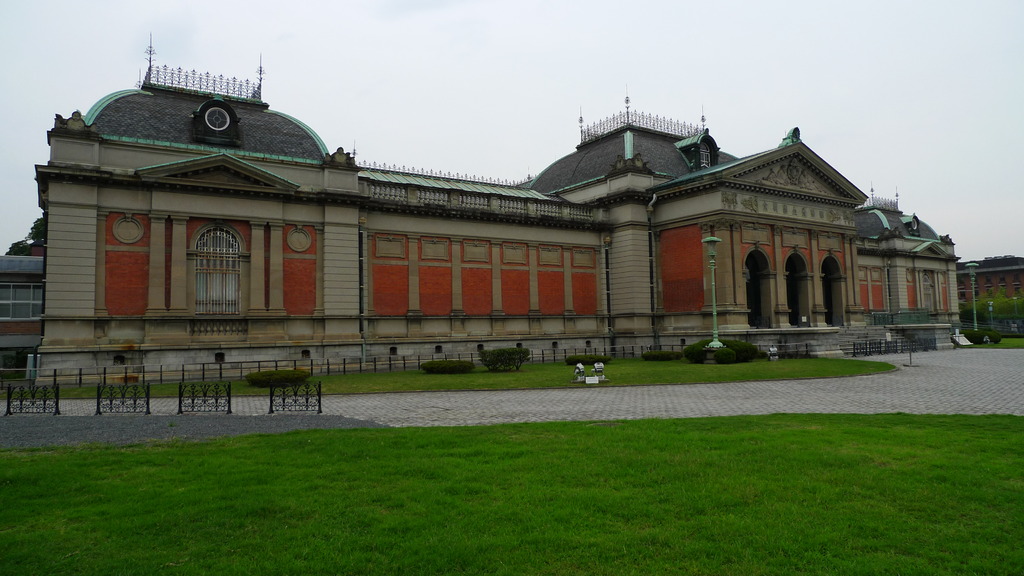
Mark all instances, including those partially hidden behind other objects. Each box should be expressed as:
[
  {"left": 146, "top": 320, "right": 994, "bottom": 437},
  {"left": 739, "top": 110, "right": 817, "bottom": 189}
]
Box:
[{"left": 196, "top": 227, "right": 241, "bottom": 315}]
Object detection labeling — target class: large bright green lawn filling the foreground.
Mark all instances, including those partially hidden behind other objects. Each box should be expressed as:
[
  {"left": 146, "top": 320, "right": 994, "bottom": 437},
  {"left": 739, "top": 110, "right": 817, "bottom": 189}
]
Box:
[{"left": 0, "top": 414, "right": 1024, "bottom": 576}]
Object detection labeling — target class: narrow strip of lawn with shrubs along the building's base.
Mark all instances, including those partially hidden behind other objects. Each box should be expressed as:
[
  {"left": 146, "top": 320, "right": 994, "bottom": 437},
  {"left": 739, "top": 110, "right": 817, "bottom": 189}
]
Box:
[{"left": 54, "top": 358, "right": 893, "bottom": 398}]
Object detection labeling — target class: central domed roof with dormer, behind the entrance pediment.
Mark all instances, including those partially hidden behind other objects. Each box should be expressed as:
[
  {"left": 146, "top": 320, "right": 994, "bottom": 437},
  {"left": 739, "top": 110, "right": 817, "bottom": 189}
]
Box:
[{"left": 528, "top": 119, "right": 735, "bottom": 194}]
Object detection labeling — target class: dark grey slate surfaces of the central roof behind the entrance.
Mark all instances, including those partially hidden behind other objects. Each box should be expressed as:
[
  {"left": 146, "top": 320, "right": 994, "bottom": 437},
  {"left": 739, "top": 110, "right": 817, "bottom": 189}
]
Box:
[{"left": 529, "top": 126, "right": 734, "bottom": 194}]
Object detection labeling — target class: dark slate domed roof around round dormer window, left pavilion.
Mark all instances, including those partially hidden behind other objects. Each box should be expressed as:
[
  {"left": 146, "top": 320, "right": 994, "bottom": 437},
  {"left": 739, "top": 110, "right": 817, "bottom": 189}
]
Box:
[{"left": 85, "top": 84, "right": 328, "bottom": 162}]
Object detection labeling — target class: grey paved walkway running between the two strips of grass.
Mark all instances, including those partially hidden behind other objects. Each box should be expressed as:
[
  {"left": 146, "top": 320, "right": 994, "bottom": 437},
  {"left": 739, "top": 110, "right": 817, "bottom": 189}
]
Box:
[{"left": 0, "top": 348, "right": 1024, "bottom": 447}]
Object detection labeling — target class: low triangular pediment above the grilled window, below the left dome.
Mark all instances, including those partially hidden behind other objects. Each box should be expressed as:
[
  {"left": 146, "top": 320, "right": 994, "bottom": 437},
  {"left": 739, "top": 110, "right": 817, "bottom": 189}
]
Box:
[{"left": 136, "top": 154, "right": 299, "bottom": 193}]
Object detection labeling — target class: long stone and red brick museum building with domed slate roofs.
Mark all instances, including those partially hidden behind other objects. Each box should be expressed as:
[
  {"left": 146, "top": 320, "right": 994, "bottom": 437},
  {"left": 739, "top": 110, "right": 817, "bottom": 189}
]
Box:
[{"left": 36, "top": 63, "right": 956, "bottom": 368}]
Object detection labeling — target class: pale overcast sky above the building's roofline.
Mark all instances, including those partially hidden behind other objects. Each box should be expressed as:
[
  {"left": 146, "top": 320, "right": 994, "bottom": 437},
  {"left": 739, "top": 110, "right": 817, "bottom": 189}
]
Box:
[{"left": 0, "top": 0, "right": 1024, "bottom": 259}]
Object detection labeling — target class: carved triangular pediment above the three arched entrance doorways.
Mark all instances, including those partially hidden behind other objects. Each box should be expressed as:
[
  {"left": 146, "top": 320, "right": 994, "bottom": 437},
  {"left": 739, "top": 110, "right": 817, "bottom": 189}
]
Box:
[{"left": 728, "top": 143, "right": 867, "bottom": 205}]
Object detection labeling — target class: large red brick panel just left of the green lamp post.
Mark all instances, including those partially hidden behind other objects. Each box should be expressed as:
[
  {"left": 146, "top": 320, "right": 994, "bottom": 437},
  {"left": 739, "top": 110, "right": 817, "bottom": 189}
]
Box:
[{"left": 658, "top": 225, "right": 703, "bottom": 313}]
